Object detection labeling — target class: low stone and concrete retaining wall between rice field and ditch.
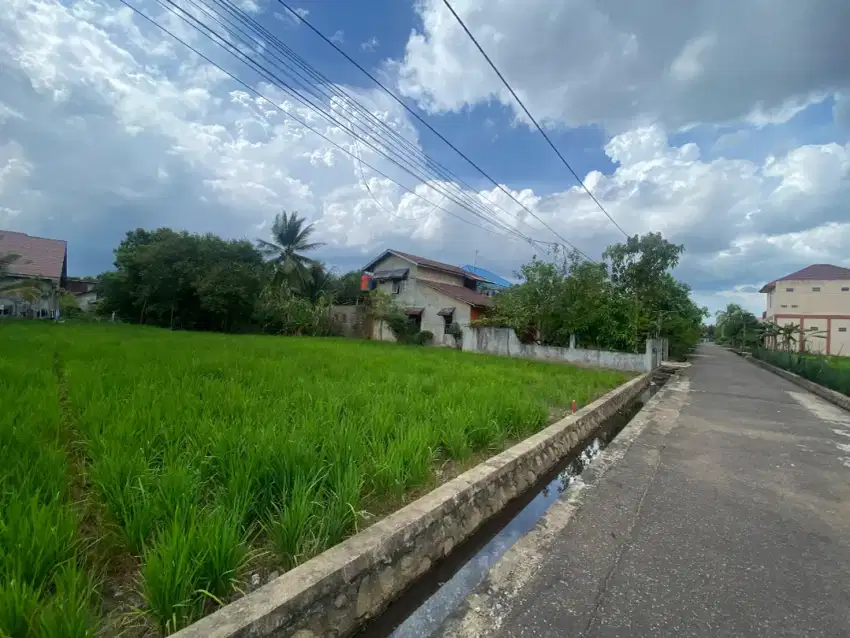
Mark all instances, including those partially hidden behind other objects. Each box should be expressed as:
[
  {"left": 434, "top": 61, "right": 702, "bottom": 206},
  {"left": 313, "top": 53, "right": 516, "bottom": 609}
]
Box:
[{"left": 174, "top": 374, "right": 650, "bottom": 638}]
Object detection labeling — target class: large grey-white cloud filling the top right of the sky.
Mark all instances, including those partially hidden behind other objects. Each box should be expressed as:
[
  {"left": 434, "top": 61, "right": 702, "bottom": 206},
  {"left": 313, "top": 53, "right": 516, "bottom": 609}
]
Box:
[{"left": 397, "top": 0, "right": 850, "bottom": 131}]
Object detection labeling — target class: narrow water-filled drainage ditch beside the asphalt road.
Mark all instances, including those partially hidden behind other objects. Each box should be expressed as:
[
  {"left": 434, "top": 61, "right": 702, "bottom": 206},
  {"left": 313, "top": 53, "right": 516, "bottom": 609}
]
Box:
[{"left": 357, "top": 367, "right": 675, "bottom": 638}]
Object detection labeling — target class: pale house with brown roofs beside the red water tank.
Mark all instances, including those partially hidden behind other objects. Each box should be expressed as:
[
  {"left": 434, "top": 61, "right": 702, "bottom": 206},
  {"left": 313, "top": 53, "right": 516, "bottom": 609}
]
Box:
[{"left": 363, "top": 250, "right": 493, "bottom": 343}]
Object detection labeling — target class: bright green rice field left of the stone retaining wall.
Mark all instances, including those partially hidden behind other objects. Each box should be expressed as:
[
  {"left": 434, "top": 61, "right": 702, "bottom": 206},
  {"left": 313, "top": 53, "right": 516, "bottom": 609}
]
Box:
[{"left": 0, "top": 322, "right": 627, "bottom": 636}]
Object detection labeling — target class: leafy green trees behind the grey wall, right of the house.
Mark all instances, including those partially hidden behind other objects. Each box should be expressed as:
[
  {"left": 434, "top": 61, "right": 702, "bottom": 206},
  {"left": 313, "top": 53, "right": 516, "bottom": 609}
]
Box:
[{"left": 480, "top": 233, "right": 708, "bottom": 357}]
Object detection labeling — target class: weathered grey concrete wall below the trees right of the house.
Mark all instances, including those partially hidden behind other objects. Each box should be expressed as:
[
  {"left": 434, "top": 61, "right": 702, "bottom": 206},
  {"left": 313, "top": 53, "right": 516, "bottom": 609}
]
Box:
[{"left": 463, "top": 327, "right": 667, "bottom": 372}]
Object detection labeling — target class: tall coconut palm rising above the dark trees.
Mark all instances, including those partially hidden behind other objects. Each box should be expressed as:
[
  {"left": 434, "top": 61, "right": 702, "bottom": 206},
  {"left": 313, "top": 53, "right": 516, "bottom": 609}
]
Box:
[{"left": 257, "top": 211, "right": 324, "bottom": 290}]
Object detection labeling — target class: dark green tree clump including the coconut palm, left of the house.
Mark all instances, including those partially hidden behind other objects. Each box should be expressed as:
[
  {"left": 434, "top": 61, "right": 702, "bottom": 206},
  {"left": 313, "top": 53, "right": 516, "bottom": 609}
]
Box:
[{"left": 98, "top": 212, "right": 360, "bottom": 335}]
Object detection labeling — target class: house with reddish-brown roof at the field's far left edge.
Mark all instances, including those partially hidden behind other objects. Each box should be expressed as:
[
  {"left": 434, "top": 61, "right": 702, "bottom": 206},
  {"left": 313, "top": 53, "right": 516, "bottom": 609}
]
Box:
[{"left": 0, "top": 230, "right": 68, "bottom": 317}]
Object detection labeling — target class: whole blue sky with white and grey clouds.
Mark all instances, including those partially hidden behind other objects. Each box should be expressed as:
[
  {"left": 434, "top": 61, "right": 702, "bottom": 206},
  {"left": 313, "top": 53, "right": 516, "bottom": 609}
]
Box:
[{"left": 0, "top": 0, "right": 850, "bottom": 312}]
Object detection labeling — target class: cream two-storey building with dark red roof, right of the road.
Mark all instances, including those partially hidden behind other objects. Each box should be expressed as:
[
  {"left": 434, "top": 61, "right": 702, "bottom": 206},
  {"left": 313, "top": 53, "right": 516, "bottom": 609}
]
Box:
[{"left": 760, "top": 264, "right": 850, "bottom": 356}]
